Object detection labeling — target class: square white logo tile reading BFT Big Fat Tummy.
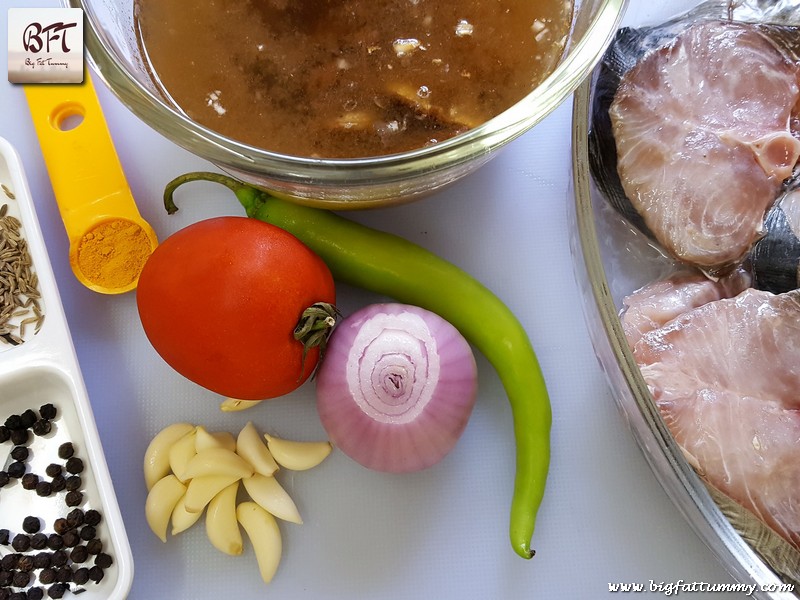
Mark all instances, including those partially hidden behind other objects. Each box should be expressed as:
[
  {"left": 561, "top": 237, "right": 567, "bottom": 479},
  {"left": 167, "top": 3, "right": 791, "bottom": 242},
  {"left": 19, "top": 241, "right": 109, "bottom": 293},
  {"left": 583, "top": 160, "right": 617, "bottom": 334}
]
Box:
[{"left": 8, "top": 8, "right": 83, "bottom": 83}]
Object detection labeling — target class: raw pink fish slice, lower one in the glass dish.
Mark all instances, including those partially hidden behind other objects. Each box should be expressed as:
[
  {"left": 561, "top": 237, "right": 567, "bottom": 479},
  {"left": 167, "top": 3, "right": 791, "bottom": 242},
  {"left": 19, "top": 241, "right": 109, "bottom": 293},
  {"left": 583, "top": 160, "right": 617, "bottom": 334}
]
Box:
[{"left": 623, "top": 288, "right": 800, "bottom": 548}]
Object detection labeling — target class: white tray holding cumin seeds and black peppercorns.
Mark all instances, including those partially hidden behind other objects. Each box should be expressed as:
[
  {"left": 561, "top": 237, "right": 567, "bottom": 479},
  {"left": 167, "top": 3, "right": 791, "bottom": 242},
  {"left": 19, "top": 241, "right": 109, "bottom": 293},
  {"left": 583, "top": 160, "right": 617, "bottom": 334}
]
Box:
[{"left": 0, "top": 138, "right": 133, "bottom": 600}]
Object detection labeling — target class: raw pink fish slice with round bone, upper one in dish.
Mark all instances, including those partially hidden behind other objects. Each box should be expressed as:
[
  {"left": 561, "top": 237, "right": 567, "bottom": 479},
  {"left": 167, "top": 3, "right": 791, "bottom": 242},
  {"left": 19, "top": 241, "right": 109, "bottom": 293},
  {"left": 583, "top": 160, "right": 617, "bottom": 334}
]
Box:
[{"left": 609, "top": 20, "right": 800, "bottom": 276}]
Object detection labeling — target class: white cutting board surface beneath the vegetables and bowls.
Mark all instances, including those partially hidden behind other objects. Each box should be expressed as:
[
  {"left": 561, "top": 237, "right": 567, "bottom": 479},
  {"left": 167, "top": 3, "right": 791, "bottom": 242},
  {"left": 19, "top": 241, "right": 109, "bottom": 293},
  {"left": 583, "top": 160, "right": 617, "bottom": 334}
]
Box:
[{"left": 0, "top": 0, "right": 732, "bottom": 600}]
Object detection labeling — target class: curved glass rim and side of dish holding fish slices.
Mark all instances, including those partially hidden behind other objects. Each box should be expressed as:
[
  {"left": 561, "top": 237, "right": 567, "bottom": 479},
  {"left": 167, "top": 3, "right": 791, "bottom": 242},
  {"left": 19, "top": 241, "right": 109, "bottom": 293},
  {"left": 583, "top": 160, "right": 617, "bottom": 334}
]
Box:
[{"left": 569, "top": 0, "right": 800, "bottom": 600}]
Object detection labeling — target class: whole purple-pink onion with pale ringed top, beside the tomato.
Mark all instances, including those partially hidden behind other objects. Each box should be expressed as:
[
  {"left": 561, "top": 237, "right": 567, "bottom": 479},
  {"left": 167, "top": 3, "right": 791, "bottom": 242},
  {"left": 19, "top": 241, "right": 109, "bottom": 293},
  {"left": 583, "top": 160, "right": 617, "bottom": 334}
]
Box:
[{"left": 317, "top": 303, "right": 477, "bottom": 473}]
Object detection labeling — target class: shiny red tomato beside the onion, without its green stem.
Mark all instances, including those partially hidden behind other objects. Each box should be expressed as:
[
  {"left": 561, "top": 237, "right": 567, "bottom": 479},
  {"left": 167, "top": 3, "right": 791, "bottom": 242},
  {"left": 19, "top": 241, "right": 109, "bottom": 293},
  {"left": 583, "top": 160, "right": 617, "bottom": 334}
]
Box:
[{"left": 136, "top": 217, "right": 336, "bottom": 400}]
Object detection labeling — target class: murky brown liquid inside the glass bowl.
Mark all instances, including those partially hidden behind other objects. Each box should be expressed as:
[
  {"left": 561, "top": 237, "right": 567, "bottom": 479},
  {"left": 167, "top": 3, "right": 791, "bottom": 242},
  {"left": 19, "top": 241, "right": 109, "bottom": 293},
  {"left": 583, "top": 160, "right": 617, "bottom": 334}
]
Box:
[{"left": 136, "top": 0, "right": 572, "bottom": 158}]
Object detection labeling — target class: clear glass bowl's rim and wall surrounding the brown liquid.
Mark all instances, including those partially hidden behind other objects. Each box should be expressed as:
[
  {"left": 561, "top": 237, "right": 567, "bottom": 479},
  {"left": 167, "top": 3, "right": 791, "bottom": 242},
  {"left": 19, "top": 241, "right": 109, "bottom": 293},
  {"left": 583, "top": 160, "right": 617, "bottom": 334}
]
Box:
[{"left": 63, "top": 0, "right": 627, "bottom": 209}]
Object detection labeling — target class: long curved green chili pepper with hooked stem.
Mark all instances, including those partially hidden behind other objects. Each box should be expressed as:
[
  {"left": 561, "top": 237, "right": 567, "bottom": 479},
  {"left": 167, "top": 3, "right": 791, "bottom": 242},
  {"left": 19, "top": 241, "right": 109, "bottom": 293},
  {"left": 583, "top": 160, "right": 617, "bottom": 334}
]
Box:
[{"left": 164, "top": 173, "right": 552, "bottom": 558}]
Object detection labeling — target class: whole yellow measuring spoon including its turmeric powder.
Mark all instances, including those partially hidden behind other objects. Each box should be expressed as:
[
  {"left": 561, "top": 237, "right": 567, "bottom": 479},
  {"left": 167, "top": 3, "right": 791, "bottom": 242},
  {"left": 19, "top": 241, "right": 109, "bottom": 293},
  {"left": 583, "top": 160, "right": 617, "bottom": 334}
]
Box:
[{"left": 23, "top": 72, "right": 158, "bottom": 294}]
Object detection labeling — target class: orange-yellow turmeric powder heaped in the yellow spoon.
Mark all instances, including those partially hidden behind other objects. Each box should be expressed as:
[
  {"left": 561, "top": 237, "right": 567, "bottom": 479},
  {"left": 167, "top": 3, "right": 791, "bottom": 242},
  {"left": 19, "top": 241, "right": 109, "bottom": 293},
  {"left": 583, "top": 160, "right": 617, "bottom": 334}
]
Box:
[{"left": 76, "top": 219, "right": 152, "bottom": 289}]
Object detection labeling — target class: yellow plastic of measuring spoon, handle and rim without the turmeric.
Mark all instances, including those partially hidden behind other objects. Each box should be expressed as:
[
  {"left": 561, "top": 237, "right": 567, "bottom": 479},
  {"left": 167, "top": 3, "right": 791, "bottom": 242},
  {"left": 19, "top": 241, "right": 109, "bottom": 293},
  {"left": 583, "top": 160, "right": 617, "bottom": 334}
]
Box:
[{"left": 23, "top": 71, "right": 158, "bottom": 293}]
